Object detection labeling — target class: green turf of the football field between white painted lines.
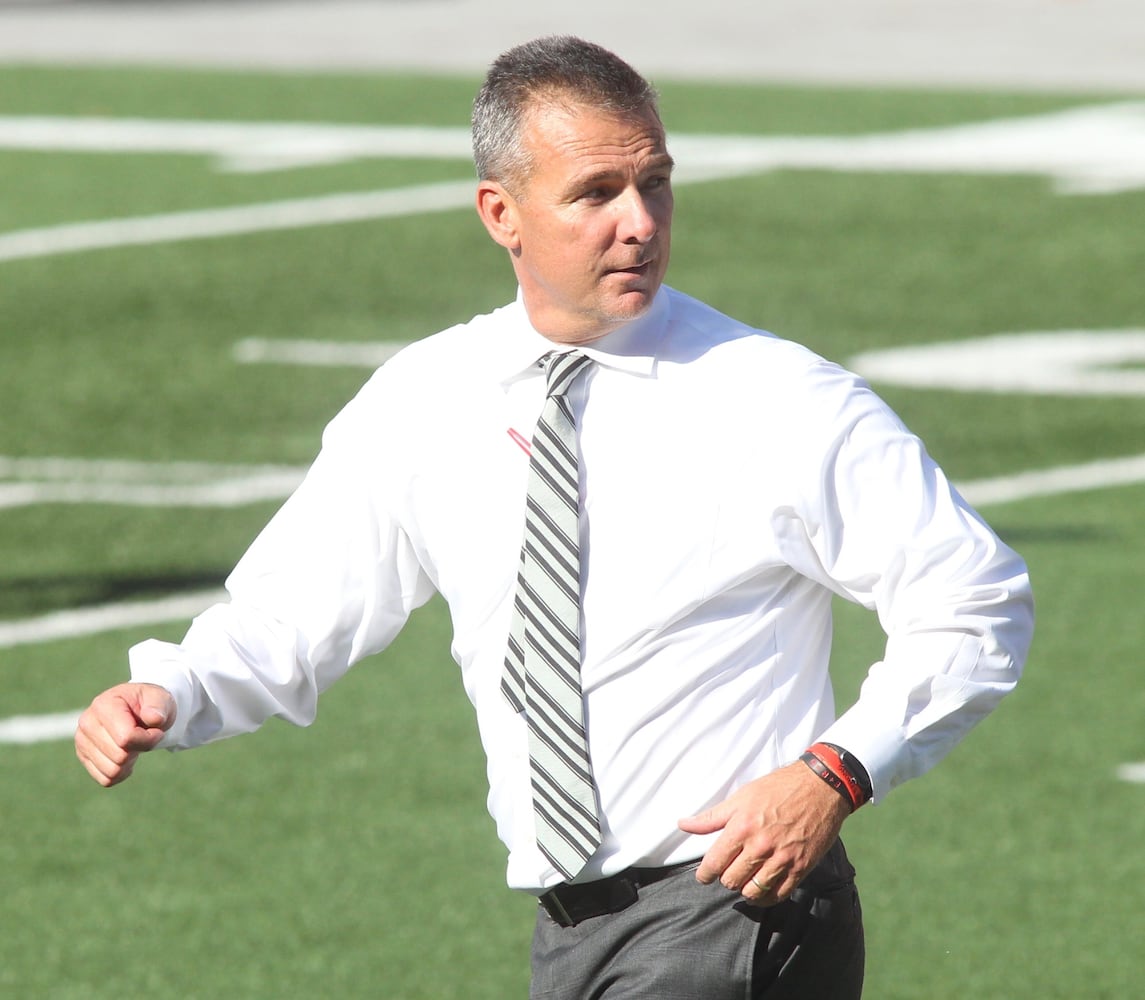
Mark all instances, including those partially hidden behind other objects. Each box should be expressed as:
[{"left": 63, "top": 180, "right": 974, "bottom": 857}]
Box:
[{"left": 0, "top": 68, "right": 1145, "bottom": 1000}]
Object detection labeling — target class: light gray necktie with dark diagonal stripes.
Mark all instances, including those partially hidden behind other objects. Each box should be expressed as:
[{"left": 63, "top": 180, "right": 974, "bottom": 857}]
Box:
[{"left": 502, "top": 352, "right": 600, "bottom": 879}]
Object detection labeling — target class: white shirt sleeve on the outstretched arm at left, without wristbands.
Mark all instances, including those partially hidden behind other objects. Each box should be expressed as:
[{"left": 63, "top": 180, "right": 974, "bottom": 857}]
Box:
[{"left": 131, "top": 394, "right": 433, "bottom": 747}]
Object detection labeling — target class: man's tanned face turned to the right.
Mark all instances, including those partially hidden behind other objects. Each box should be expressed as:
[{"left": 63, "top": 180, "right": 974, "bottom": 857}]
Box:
[{"left": 492, "top": 104, "right": 672, "bottom": 344}]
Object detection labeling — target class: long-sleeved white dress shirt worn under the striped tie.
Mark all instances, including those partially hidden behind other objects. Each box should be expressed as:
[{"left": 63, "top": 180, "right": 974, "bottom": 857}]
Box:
[{"left": 132, "top": 288, "right": 1033, "bottom": 891}]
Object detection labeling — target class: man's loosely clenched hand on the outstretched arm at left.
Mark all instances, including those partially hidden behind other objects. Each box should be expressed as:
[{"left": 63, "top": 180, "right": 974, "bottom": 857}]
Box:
[{"left": 76, "top": 684, "right": 175, "bottom": 787}]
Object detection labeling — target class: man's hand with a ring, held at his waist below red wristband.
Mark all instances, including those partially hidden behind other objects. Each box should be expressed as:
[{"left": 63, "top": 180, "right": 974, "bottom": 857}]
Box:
[{"left": 679, "top": 762, "right": 851, "bottom": 906}]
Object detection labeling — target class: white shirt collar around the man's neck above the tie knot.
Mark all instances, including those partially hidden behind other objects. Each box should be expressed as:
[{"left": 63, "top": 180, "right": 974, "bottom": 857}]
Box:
[{"left": 496, "top": 286, "right": 669, "bottom": 385}]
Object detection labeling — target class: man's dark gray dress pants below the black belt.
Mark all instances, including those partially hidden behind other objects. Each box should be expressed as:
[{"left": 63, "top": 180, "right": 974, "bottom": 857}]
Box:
[{"left": 529, "top": 842, "right": 864, "bottom": 1000}]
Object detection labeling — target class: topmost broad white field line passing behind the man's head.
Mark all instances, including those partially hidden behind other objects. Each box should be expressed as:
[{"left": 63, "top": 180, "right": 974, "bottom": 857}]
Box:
[{"left": 0, "top": 101, "right": 1145, "bottom": 194}]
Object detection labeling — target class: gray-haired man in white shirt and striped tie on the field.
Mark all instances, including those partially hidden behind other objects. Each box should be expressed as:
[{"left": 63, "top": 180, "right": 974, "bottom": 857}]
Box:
[{"left": 77, "top": 38, "right": 1033, "bottom": 1000}]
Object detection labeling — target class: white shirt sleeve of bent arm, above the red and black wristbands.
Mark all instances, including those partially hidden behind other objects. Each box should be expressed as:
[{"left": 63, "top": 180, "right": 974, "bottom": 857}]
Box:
[{"left": 776, "top": 365, "right": 1033, "bottom": 800}]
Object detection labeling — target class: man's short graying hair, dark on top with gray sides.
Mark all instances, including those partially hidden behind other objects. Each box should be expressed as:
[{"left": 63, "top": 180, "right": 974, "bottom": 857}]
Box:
[{"left": 472, "top": 34, "right": 660, "bottom": 193}]
